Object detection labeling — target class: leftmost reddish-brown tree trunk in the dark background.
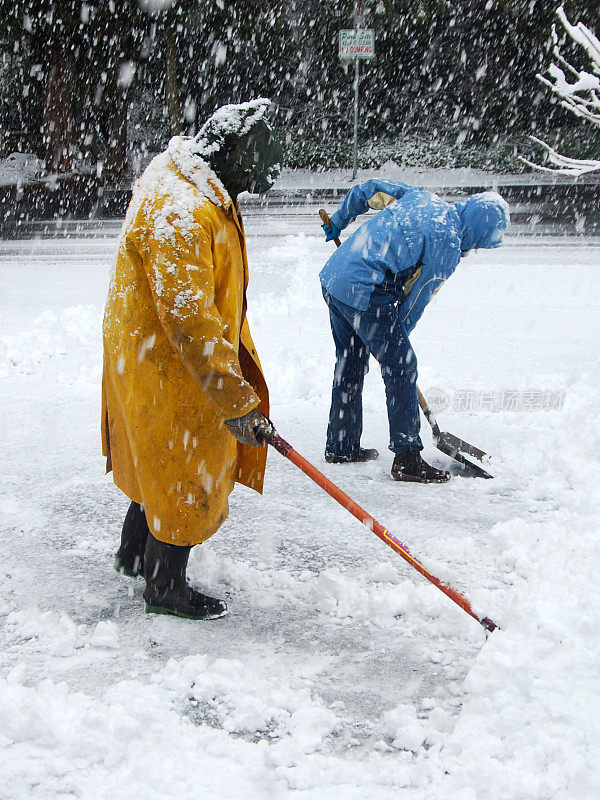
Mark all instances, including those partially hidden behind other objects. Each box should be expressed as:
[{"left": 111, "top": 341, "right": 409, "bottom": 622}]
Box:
[{"left": 42, "top": 45, "right": 74, "bottom": 172}]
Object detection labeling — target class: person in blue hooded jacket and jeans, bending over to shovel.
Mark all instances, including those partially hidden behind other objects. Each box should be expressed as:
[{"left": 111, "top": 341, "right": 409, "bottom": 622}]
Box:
[{"left": 319, "top": 179, "right": 510, "bottom": 483}]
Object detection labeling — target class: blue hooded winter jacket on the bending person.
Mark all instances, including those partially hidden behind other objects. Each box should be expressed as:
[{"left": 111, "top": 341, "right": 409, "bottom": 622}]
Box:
[{"left": 319, "top": 179, "right": 509, "bottom": 333}]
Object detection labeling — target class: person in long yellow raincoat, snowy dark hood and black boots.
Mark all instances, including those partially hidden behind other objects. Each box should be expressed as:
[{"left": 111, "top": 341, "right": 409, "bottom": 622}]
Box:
[{"left": 102, "top": 98, "right": 281, "bottom": 619}]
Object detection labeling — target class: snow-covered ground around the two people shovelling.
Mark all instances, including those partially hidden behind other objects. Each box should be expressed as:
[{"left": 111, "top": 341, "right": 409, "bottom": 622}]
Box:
[{"left": 0, "top": 214, "right": 600, "bottom": 800}]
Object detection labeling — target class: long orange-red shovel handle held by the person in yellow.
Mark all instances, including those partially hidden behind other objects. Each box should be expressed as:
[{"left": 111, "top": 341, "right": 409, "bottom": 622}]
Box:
[{"left": 260, "top": 423, "right": 498, "bottom": 633}]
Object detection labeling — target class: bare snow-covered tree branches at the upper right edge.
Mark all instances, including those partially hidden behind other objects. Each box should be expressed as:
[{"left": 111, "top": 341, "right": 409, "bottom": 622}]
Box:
[{"left": 521, "top": 6, "right": 600, "bottom": 176}]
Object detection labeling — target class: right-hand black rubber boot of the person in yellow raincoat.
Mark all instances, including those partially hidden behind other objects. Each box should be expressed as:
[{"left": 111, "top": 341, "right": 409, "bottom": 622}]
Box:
[{"left": 144, "top": 533, "right": 227, "bottom": 619}]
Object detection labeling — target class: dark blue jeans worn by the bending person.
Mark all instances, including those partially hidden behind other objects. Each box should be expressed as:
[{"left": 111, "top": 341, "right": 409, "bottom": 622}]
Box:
[{"left": 323, "top": 285, "right": 423, "bottom": 458}]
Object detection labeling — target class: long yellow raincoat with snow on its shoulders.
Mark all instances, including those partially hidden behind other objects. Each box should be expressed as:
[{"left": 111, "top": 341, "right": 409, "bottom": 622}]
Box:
[{"left": 102, "top": 137, "right": 268, "bottom": 545}]
